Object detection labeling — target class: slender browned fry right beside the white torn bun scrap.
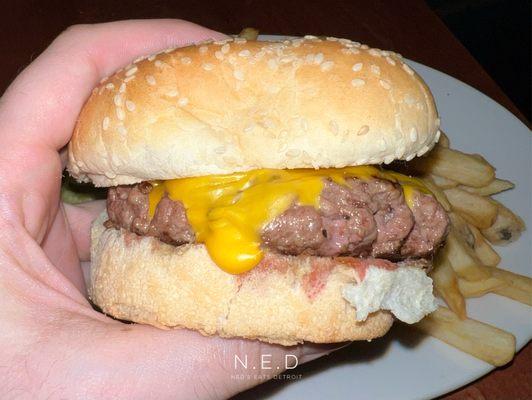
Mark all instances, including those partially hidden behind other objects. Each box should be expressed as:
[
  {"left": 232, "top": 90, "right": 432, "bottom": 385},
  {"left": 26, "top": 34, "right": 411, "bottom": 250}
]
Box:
[{"left": 431, "top": 253, "right": 467, "bottom": 319}]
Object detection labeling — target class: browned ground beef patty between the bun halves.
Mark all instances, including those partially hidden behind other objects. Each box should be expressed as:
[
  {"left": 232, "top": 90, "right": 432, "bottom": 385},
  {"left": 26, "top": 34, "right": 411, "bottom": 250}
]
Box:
[{"left": 106, "top": 178, "right": 449, "bottom": 259}]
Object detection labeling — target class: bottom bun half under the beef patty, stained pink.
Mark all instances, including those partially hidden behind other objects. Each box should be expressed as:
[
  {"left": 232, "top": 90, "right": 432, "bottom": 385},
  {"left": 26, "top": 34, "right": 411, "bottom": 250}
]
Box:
[{"left": 89, "top": 213, "right": 393, "bottom": 346}]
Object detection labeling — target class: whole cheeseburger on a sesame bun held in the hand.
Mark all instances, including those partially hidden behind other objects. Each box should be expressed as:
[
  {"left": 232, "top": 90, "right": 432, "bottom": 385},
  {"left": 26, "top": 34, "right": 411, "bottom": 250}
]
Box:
[{"left": 68, "top": 36, "right": 448, "bottom": 345}]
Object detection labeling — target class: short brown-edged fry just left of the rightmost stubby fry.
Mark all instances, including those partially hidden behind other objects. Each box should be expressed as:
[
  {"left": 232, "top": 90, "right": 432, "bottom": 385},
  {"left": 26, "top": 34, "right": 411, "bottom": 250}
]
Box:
[{"left": 444, "top": 188, "right": 497, "bottom": 229}]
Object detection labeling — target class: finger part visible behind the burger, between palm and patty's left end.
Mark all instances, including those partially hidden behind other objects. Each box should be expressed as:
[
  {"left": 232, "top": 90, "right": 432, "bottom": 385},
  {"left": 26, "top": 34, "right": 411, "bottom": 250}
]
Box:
[{"left": 64, "top": 200, "right": 105, "bottom": 261}]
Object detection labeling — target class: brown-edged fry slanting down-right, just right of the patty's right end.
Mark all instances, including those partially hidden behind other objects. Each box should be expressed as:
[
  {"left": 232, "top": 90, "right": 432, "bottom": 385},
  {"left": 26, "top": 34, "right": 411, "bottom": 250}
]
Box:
[{"left": 440, "top": 227, "right": 491, "bottom": 281}]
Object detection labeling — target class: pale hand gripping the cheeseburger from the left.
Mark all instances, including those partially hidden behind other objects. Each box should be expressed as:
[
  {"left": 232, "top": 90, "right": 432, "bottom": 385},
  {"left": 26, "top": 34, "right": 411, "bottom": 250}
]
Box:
[{"left": 0, "top": 20, "right": 342, "bottom": 399}]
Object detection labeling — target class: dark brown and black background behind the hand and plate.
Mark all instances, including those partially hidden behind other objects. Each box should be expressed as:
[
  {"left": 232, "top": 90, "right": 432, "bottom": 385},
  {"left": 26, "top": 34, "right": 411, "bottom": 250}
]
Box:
[{"left": 0, "top": 0, "right": 531, "bottom": 120}]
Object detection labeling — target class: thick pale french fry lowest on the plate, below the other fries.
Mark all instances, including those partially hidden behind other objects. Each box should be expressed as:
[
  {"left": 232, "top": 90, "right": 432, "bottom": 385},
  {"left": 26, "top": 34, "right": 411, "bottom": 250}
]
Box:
[{"left": 414, "top": 307, "right": 515, "bottom": 367}]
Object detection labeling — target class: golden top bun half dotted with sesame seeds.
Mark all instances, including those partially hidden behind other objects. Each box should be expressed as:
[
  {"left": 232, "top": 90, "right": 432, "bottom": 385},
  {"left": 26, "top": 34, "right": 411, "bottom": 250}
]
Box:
[{"left": 68, "top": 36, "right": 439, "bottom": 186}]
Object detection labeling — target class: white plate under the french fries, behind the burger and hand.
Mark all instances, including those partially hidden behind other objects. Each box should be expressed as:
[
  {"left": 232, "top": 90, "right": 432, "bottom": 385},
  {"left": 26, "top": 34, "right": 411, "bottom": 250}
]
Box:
[{"left": 238, "top": 36, "right": 532, "bottom": 400}]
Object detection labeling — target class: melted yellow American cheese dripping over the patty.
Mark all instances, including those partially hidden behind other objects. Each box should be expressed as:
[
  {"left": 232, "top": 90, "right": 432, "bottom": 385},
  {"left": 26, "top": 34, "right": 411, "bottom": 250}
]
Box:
[{"left": 149, "top": 166, "right": 429, "bottom": 274}]
